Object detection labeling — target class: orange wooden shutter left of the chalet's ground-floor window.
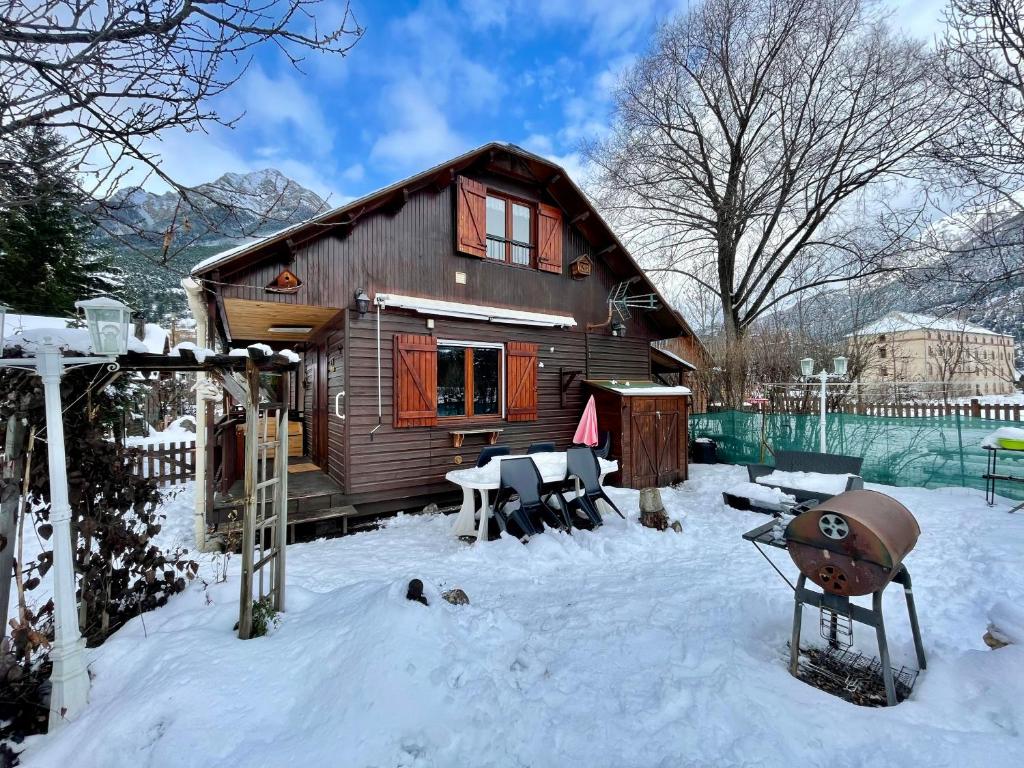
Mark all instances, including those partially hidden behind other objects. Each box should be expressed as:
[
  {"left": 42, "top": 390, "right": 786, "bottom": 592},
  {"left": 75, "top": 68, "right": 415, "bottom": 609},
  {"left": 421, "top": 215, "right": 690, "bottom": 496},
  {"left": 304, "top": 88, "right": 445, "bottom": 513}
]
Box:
[{"left": 394, "top": 334, "right": 437, "bottom": 427}]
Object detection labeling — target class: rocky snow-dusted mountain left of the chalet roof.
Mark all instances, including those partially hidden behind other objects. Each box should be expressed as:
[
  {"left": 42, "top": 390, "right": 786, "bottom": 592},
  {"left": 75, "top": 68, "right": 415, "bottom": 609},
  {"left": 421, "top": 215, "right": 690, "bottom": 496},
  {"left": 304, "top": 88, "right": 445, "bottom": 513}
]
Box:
[{"left": 95, "top": 169, "right": 327, "bottom": 321}]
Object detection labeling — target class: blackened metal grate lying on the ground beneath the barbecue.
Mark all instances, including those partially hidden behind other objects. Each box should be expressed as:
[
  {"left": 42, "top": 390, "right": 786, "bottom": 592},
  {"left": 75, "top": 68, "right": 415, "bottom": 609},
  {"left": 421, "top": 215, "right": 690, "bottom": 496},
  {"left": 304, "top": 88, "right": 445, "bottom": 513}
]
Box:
[{"left": 797, "top": 647, "right": 918, "bottom": 707}]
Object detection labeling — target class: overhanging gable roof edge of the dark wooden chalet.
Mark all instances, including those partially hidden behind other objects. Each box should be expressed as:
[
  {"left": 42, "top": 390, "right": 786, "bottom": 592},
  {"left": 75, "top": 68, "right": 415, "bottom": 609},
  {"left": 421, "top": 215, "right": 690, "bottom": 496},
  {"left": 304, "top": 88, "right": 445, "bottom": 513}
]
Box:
[{"left": 190, "top": 141, "right": 693, "bottom": 336}]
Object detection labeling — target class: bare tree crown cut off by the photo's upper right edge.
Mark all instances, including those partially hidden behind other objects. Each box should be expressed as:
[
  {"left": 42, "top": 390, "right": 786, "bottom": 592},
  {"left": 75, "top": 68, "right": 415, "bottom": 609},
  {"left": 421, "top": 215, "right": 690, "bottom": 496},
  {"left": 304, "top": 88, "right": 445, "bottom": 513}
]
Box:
[{"left": 913, "top": 0, "right": 1024, "bottom": 303}]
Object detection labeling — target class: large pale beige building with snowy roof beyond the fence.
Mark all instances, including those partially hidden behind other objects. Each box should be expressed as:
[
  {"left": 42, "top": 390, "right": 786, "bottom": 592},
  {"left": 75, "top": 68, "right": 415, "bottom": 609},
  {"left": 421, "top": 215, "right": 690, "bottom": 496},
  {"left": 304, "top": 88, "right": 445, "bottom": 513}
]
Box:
[{"left": 847, "top": 312, "right": 1018, "bottom": 399}]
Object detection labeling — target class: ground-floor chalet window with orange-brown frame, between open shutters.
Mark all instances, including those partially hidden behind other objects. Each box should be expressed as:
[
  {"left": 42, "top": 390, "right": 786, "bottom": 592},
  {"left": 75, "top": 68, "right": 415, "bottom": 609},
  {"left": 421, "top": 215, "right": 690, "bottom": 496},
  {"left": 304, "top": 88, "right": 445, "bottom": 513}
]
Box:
[{"left": 437, "top": 342, "right": 503, "bottom": 418}]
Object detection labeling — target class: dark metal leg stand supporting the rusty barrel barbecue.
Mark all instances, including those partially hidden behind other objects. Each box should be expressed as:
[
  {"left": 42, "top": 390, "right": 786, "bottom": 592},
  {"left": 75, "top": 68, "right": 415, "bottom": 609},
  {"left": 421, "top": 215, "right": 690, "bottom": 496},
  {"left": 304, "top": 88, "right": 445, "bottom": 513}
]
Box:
[{"left": 790, "top": 565, "right": 928, "bottom": 707}]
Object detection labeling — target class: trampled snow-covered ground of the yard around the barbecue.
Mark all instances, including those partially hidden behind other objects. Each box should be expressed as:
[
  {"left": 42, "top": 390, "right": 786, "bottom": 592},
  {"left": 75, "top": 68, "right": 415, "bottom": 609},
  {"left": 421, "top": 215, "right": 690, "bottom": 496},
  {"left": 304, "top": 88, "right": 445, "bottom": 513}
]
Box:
[{"left": 9, "top": 466, "right": 1024, "bottom": 768}]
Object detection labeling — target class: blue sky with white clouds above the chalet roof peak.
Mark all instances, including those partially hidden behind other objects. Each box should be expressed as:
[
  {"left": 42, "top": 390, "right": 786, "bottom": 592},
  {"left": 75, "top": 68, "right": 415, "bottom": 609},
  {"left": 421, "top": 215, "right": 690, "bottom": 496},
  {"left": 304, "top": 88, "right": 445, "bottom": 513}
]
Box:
[{"left": 146, "top": 0, "right": 943, "bottom": 205}]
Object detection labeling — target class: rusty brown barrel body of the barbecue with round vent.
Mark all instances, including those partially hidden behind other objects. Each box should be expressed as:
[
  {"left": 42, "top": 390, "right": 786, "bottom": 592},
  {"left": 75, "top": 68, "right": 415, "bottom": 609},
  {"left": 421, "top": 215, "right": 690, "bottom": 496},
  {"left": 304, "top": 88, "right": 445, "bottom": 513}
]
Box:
[{"left": 785, "top": 490, "right": 921, "bottom": 596}]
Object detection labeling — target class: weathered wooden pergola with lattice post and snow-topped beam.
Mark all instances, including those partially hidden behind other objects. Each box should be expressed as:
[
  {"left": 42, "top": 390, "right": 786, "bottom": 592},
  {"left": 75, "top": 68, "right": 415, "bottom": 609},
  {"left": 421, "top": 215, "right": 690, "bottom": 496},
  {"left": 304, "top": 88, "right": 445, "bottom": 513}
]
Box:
[{"left": 118, "top": 346, "right": 298, "bottom": 639}]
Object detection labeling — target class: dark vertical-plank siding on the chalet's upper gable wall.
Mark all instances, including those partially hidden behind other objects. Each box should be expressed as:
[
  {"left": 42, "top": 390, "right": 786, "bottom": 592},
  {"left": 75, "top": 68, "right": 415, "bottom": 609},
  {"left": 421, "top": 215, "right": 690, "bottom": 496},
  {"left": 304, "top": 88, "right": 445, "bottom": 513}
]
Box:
[{"left": 220, "top": 179, "right": 657, "bottom": 341}]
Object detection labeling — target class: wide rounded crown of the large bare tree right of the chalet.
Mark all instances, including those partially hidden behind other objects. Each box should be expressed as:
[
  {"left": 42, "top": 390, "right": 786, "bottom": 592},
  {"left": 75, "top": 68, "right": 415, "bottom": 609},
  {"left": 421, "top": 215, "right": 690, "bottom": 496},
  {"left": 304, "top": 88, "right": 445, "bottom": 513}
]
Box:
[{"left": 588, "top": 0, "right": 954, "bottom": 403}]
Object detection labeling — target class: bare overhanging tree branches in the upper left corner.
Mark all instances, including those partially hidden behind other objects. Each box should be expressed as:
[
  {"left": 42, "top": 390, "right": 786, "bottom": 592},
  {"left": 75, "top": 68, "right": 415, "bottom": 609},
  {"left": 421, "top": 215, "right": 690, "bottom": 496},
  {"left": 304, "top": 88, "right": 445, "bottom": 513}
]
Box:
[{"left": 0, "top": 0, "right": 362, "bottom": 262}]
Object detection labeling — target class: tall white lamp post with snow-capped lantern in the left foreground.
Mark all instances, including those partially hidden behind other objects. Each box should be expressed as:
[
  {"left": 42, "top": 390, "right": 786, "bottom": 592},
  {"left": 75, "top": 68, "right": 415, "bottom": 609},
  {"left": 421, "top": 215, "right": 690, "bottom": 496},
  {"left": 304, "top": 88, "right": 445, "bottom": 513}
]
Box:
[{"left": 0, "top": 298, "right": 131, "bottom": 731}]
